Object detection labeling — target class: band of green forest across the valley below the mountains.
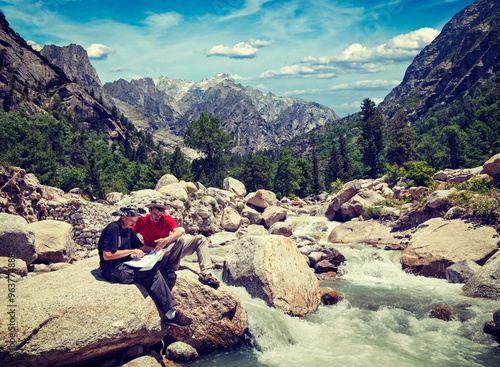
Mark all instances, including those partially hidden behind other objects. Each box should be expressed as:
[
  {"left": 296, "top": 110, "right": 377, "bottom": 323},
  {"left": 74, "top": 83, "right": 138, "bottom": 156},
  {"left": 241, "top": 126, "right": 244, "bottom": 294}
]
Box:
[{"left": 0, "top": 75, "right": 500, "bottom": 199}]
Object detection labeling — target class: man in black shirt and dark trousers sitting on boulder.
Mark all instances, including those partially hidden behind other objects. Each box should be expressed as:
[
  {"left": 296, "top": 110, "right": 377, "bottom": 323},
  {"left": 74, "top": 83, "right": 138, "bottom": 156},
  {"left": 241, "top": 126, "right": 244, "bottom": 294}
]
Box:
[{"left": 97, "top": 206, "right": 193, "bottom": 327}]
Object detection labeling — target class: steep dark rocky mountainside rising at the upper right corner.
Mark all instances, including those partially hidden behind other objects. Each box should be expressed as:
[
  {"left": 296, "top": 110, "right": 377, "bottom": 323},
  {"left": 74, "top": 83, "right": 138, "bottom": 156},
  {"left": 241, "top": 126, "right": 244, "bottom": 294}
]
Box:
[{"left": 380, "top": 0, "right": 500, "bottom": 121}]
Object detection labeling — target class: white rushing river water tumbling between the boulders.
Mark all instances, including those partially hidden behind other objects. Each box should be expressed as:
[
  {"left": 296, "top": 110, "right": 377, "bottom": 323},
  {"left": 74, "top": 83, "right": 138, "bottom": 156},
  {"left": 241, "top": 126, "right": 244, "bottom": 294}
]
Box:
[{"left": 191, "top": 218, "right": 500, "bottom": 367}]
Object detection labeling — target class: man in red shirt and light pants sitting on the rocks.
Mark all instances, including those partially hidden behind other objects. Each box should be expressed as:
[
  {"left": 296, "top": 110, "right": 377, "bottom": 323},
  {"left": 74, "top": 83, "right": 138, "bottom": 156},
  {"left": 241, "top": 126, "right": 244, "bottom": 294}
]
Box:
[{"left": 132, "top": 200, "right": 219, "bottom": 288}]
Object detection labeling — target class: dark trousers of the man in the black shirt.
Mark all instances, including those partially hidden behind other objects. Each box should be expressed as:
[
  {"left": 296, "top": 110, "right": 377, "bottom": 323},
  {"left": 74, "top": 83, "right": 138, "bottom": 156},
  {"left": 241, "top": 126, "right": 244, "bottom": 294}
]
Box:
[{"left": 113, "top": 264, "right": 177, "bottom": 316}]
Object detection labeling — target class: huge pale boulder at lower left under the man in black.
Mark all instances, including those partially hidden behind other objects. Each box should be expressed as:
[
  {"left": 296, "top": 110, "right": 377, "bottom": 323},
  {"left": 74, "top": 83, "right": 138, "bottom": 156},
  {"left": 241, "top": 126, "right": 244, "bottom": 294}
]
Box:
[{"left": 0, "top": 257, "right": 167, "bottom": 367}]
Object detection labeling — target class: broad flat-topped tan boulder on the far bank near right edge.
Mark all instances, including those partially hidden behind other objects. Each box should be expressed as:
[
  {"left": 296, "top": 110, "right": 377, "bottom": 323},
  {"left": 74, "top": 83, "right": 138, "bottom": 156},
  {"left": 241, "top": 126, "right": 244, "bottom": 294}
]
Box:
[{"left": 400, "top": 218, "right": 498, "bottom": 278}]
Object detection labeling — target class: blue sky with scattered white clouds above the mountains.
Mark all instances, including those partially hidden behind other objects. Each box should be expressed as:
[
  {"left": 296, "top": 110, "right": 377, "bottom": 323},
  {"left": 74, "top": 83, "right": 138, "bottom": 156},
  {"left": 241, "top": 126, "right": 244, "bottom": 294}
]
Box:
[{"left": 0, "top": 0, "right": 473, "bottom": 117}]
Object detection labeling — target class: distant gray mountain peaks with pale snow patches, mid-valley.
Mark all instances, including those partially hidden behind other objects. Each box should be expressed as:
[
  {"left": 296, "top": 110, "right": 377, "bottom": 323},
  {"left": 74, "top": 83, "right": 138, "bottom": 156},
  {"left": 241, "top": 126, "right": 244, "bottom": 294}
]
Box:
[{"left": 104, "top": 74, "right": 338, "bottom": 152}]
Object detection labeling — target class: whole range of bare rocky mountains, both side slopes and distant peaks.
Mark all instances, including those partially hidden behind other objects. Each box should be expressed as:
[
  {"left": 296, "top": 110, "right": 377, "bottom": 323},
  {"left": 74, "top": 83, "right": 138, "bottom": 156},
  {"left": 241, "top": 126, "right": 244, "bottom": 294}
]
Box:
[{"left": 0, "top": 0, "right": 500, "bottom": 157}]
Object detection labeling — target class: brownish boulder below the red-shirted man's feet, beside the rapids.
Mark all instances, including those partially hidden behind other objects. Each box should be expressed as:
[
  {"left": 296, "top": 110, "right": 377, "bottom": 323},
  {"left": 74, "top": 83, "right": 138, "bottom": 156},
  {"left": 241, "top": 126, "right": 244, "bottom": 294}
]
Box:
[{"left": 167, "top": 268, "right": 248, "bottom": 353}]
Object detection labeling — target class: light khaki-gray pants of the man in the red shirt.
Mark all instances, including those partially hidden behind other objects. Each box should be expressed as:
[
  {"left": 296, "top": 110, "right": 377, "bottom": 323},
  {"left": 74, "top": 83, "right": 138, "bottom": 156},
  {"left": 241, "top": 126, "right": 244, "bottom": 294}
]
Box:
[{"left": 160, "top": 234, "right": 212, "bottom": 274}]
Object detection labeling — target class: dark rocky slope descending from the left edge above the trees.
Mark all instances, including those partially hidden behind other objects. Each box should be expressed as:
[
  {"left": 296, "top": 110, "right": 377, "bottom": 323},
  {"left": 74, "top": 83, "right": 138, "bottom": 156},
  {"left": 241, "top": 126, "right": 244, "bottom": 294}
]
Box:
[{"left": 0, "top": 13, "right": 123, "bottom": 138}]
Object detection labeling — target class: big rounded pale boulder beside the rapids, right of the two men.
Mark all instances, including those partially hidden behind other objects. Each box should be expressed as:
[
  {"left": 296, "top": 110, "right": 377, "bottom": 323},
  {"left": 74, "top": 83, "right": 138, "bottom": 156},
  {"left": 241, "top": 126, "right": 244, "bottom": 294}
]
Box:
[{"left": 223, "top": 235, "right": 321, "bottom": 316}]
